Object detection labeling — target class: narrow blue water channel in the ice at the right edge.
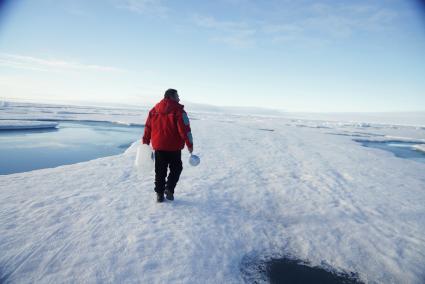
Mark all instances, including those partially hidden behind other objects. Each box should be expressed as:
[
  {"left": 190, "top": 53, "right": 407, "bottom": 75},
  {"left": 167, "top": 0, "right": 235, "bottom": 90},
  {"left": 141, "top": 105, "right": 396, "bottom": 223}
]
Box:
[{"left": 355, "top": 140, "right": 425, "bottom": 163}]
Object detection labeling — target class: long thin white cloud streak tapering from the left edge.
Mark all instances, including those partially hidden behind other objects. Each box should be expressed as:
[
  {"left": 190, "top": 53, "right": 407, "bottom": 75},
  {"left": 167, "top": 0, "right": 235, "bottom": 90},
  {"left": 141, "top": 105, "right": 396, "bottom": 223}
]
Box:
[{"left": 0, "top": 53, "right": 125, "bottom": 72}]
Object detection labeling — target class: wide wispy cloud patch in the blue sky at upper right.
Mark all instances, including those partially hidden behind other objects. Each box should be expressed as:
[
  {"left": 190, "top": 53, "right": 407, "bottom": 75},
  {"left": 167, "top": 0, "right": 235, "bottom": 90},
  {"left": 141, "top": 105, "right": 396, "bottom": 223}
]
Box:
[{"left": 192, "top": 3, "right": 399, "bottom": 47}]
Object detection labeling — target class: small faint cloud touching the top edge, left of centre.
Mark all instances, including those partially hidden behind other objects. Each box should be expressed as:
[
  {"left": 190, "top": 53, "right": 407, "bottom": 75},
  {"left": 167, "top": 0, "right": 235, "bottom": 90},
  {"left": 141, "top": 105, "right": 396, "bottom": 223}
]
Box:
[{"left": 115, "top": 0, "right": 169, "bottom": 17}]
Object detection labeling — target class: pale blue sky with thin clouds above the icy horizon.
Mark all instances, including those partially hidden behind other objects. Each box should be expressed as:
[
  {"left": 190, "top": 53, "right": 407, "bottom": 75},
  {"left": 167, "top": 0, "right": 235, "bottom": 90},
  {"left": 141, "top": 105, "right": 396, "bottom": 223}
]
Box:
[{"left": 0, "top": 0, "right": 425, "bottom": 112}]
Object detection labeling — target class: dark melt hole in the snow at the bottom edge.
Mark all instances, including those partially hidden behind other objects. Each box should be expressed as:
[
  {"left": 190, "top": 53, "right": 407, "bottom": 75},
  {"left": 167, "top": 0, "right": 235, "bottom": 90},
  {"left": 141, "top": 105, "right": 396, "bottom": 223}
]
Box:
[{"left": 266, "top": 259, "right": 361, "bottom": 284}]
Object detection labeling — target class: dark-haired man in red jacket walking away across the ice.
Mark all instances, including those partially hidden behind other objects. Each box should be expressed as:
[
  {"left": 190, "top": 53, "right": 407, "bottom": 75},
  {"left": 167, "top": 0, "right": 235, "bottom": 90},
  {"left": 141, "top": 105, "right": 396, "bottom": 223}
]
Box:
[{"left": 142, "top": 89, "right": 193, "bottom": 202}]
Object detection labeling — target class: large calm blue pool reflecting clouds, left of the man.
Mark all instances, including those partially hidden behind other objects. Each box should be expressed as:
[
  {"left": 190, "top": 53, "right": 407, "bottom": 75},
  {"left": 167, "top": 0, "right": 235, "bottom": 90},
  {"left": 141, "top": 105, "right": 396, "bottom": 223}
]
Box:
[{"left": 0, "top": 122, "right": 143, "bottom": 175}]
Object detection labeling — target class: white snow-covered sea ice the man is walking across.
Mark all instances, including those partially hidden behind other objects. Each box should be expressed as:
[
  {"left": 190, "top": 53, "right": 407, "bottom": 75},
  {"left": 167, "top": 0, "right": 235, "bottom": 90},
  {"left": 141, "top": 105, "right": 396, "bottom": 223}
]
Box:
[{"left": 0, "top": 103, "right": 425, "bottom": 283}]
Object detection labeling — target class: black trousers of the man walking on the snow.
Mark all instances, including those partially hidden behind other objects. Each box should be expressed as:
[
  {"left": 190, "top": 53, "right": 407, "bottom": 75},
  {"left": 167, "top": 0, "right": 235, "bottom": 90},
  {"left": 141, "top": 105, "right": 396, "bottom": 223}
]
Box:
[{"left": 155, "top": 151, "right": 183, "bottom": 193}]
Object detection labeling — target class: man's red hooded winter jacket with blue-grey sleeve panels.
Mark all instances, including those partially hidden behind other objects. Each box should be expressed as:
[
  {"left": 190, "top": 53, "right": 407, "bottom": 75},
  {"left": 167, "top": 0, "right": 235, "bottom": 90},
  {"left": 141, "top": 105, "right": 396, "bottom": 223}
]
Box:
[{"left": 142, "top": 99, "right": 193, "bottom": 151}]
